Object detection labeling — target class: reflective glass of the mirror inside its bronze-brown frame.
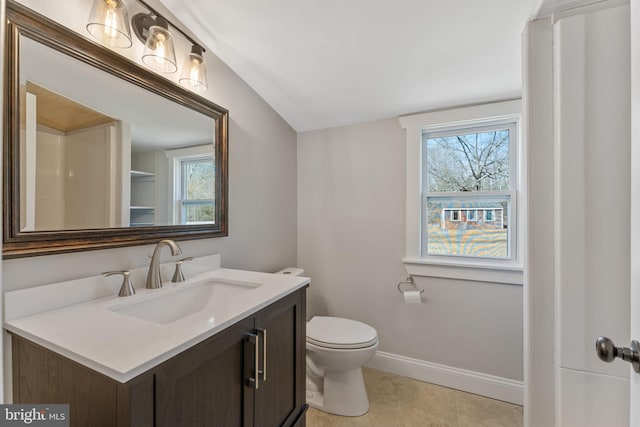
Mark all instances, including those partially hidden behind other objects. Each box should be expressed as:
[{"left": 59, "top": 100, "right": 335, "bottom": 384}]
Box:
[{"left": 19, "top": 37, "right": 216, "bottom": 231}]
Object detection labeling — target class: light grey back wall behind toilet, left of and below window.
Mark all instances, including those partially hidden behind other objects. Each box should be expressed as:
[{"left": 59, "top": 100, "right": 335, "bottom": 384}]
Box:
[{"left": 298, "top": 118, "right": 523, "bottom": 398}]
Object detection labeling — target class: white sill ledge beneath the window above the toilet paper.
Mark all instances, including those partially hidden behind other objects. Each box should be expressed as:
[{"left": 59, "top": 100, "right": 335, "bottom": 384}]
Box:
[{"left": 402, "top": 258, "right": 523, "bottom": 285}]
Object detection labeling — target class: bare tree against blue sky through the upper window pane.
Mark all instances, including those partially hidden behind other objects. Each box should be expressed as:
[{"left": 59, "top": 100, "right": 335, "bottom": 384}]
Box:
[{"left": 426, "top": 129, "right": 509, "bottom": 192}]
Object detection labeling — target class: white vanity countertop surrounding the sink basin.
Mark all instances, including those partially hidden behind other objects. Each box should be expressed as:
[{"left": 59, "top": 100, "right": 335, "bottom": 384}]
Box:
[{"left": 5, "top": 262, "right": 309, "bottom": 383}]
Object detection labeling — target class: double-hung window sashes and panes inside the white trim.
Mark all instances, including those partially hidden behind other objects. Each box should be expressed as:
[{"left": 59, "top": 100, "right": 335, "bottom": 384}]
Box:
[{"left": 421, "top": 121, "right": 517, "bottom": 259}]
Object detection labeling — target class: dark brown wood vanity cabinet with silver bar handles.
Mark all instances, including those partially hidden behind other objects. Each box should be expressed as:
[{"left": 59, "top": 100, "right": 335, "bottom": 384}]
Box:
[{"left": 13, "top": 288, "right": 306, "bottom": 427}]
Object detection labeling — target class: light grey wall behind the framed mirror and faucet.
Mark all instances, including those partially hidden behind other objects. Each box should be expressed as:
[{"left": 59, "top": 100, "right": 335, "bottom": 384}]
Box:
[{"left": 2, "top": 0, "right": 297, "bottom": 402}]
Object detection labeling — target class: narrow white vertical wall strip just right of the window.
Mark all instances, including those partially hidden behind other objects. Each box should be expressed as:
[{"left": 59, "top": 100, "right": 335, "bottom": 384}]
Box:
[{"left": 522, "top": 18, "right": 555, "bottom": 427}]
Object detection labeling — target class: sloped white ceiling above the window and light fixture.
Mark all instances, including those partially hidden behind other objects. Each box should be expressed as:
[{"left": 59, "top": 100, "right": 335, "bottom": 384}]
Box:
[{"left": 161, "top": 0, "right": 543, "bottom": 131}]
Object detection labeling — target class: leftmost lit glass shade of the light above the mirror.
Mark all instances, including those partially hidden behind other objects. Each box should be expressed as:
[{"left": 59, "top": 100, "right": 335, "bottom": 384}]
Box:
[{"left": 87, "top": 0, "right": 132, "bottom": 48}]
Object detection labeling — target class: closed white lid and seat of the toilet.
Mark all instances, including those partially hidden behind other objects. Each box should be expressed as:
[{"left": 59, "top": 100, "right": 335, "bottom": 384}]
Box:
[{"left": 307, "top": 316, "right": 378, "bottom": 348}]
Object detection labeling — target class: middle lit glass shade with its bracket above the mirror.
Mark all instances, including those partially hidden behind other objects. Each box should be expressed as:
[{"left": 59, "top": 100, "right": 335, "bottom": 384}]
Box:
[{"left": 131, "top": 13, "right": 178, "bottom": 74}]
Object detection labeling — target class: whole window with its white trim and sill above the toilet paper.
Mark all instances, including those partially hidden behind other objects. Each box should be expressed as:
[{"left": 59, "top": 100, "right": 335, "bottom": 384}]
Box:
[{"left": 399, "top": 100, "right": 524, "bottom": 284}]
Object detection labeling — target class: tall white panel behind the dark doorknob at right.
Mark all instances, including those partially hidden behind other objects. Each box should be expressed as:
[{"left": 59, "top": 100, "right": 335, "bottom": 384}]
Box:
[{"left": 553, "top": 0, "right": 640, "bottom": 427}]
